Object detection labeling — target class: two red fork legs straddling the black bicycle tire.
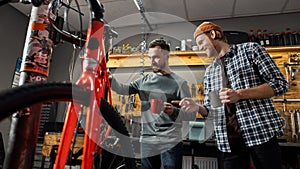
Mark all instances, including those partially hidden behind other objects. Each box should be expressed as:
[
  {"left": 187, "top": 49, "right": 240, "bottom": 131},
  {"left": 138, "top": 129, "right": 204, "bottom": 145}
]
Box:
[{"left": 54, "top": 93, "right": 102, "bottom": 169}]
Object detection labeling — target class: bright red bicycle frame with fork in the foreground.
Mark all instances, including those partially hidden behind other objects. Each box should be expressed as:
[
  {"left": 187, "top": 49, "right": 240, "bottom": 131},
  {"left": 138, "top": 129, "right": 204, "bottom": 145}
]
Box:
[{"left": 54, "top": 0, "right": 112, "bottom": 169}]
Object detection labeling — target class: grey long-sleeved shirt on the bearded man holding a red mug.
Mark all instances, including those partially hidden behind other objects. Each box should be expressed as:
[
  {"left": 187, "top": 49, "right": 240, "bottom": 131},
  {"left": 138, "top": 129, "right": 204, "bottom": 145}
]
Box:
[{"left": 111, "top": 73, "right": 195, "bottom": 144}]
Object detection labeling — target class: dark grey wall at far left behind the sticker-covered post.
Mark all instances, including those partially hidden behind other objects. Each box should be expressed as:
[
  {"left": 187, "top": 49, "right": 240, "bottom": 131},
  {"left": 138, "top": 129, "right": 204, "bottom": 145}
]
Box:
[{"left": 0, "top": 5, "right": 28, "bottom": 155}]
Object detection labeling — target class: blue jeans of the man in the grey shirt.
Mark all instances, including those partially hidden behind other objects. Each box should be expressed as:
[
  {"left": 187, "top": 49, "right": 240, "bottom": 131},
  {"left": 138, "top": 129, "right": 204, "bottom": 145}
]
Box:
[{"left": 141, "top": 143, "right": 183, "bottom": 169}]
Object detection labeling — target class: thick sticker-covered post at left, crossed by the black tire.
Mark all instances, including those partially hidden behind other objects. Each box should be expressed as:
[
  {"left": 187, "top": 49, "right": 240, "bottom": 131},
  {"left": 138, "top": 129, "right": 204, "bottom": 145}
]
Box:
[{"left": 5, "top": 1, "right": 53, "bottom": 169}]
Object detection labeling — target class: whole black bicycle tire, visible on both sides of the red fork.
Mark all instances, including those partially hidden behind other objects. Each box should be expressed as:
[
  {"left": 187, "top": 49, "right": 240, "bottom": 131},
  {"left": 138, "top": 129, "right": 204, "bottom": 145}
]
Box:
[{"left": 0, "top": 82, "right": 136, "bottom": 169}]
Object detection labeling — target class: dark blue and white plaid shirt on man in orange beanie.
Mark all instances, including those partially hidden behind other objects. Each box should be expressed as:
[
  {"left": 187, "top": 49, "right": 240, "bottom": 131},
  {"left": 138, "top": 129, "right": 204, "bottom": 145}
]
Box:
[{"left": 204, "top": 42, "right": 289, "bottom": 152}]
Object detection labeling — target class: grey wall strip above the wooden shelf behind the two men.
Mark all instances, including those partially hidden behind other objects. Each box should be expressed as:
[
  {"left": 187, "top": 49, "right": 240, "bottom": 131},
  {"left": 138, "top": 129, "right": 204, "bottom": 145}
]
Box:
[{"left": 112, "top": 12, "right": 300, "bottom": 49}]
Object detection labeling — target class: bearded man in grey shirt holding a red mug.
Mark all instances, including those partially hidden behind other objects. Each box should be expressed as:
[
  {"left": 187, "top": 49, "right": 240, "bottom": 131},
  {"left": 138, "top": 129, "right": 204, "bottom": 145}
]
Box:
[{"left": 111, "top": 39, "right": 196, "bottom": 169}]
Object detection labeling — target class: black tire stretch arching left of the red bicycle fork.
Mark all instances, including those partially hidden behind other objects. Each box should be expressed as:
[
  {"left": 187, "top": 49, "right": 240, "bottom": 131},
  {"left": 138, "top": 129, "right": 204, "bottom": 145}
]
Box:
[{"left": 0, "top": 82, "right": 90, "bottom": 120}]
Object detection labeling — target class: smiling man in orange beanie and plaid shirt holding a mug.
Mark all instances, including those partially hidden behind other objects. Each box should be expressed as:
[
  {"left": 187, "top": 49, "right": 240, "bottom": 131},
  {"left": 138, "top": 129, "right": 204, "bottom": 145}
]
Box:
[{"left": 179, "top": 22, "right": 289, "bottom": 169}]
